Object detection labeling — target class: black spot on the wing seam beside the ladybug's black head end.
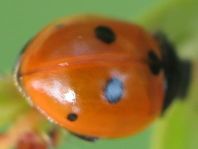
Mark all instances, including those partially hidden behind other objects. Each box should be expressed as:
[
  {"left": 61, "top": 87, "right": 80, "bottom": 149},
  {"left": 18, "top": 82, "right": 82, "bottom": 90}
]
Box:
[{"left": 148, "top": 50, "right": 162, "bottom": 75}]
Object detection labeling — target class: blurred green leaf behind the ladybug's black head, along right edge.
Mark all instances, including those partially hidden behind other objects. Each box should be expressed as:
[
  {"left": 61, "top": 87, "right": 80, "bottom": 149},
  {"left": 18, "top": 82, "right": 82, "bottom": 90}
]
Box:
[{"left": 143, "top": 0, "right": 198, "bottom": 149}]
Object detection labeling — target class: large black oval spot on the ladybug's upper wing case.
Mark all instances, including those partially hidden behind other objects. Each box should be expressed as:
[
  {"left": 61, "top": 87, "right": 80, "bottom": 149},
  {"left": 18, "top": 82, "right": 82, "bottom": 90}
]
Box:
[{"left": 95, "top": 26, "right": 116, "bottom": 44}]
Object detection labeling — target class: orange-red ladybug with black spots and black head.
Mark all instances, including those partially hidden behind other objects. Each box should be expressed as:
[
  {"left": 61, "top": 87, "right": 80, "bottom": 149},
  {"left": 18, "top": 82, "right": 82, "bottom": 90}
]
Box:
[{"left": 15, "top": 16, "right": 191, "bottom": 141}]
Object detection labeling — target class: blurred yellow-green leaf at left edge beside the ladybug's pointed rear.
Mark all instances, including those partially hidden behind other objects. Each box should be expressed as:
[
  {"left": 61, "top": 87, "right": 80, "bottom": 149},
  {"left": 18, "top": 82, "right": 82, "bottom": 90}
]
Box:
[{"left": 0, "top": 77, "right": 29, "bottom": 128}]
